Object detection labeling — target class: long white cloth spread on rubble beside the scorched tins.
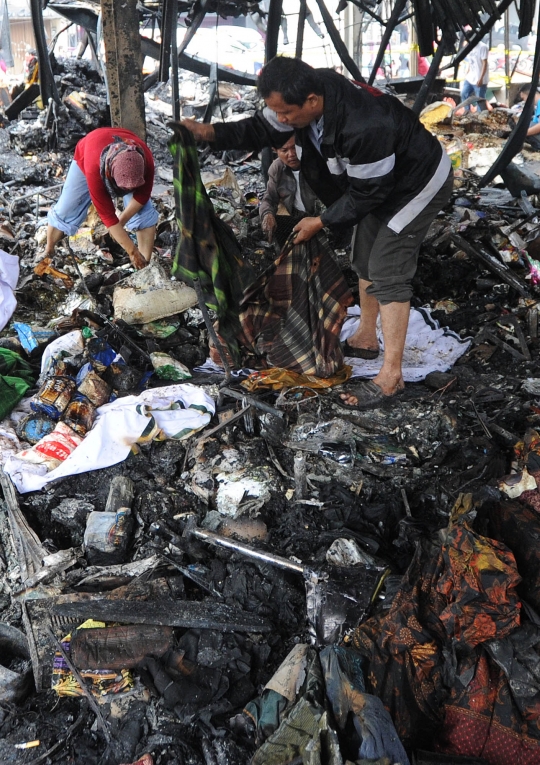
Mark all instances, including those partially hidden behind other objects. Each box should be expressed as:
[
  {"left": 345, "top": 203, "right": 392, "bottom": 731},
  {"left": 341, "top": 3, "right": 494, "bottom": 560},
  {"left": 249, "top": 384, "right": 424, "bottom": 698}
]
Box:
[{"left": 4, "top": 383, "right": 215, "bottom": 494}]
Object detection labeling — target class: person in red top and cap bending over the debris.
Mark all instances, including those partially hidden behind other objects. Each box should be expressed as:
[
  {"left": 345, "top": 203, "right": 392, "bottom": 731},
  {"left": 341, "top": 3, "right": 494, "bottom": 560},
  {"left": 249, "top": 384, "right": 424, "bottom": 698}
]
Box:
[{"left": 44, "top": 128, "right": 158, "bottom": 268}]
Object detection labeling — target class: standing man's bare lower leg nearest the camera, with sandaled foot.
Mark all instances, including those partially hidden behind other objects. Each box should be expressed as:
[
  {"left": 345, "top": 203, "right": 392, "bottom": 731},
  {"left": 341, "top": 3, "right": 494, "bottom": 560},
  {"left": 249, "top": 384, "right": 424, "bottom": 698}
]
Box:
[{"left": 341, "top": 302, "right": 410, "bottom": 406}]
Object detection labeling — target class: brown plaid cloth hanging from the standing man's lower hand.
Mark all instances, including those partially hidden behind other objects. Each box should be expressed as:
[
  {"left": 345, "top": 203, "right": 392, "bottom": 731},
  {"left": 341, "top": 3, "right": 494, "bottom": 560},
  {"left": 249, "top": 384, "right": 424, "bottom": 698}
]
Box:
[{"left": 240, "top": 234, "right": 353, "bottom": 377}]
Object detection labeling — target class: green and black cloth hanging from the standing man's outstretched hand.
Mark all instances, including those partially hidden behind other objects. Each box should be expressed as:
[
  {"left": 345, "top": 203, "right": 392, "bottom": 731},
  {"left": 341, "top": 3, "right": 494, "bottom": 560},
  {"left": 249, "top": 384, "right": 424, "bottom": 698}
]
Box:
[{"left": 168, "top": 123, "right": 254, "bottom": 356}]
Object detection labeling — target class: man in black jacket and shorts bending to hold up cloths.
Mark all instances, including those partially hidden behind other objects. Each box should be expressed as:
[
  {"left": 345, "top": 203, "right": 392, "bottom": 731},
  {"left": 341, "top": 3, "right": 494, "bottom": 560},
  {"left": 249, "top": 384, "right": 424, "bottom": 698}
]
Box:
[{"left": 184, "top": 57, "right": 452, "bottom": 406}]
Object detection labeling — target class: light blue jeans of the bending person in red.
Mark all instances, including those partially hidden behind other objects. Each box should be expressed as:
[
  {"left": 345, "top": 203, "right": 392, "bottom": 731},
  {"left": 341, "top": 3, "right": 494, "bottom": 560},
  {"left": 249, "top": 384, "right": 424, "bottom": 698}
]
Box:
[{"left": 47, "top": 161, "right": 159, "bottom": 236}]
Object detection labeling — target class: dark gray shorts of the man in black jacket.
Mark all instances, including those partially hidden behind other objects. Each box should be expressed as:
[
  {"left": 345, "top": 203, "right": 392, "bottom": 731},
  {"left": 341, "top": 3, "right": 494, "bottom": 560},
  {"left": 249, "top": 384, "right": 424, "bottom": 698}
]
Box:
[{"left": 351, "top": 172, "right": 454, "bottom": 305}]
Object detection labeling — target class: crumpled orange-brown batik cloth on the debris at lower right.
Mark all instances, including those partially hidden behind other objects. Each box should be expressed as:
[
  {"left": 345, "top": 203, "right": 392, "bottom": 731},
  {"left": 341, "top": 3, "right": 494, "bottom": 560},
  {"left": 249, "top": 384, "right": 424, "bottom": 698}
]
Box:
[{"left": 353, "top": 519, "right": 524, "bottom": 752}]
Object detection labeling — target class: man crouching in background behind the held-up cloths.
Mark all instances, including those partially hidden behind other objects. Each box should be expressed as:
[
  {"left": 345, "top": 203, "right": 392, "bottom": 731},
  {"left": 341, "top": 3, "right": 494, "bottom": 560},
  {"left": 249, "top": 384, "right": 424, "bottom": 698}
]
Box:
[{"left": 259, "top": 136, "right": 320, "bottom": 244}]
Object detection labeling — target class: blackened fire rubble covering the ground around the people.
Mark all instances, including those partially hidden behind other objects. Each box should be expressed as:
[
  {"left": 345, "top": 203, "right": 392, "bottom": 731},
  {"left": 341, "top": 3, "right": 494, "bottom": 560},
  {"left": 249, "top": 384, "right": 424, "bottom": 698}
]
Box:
[{"left": 4, "top": 61, "right": 540, "bottom": 765}]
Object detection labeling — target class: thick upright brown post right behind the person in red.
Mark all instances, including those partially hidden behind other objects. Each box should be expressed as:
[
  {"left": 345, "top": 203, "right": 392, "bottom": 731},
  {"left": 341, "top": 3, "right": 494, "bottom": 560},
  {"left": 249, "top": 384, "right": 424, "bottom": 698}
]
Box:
[{"left": 101, "top": 0, "right": 146, "bottom": 141}]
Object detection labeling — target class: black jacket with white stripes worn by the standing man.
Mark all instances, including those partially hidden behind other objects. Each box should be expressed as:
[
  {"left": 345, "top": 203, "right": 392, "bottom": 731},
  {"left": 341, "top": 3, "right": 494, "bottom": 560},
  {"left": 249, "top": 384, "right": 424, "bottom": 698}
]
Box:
[{"left": 214, "top": 69, "right": 451, "bottom": 233}]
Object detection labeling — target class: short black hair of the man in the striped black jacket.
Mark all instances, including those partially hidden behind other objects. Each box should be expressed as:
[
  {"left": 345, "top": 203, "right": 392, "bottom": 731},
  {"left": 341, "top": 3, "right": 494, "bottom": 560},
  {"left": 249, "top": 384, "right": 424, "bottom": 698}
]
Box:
[{"left": 258, "top": 56, "right": 324, "bottom": 106}]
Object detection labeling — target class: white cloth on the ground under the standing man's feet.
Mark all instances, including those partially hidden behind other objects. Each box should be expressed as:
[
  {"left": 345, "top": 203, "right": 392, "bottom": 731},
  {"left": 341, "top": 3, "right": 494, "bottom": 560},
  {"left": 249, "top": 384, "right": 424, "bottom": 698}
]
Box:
[{"left": 341, "top": 305, "right": 471, "bottom": 382}]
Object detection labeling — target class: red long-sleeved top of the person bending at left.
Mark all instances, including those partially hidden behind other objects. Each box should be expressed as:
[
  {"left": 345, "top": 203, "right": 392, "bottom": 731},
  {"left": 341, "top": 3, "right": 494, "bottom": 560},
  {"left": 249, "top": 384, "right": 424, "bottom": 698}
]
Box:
[{"left": 73, "top": 128, "right": 154, "bottom": 228}]
